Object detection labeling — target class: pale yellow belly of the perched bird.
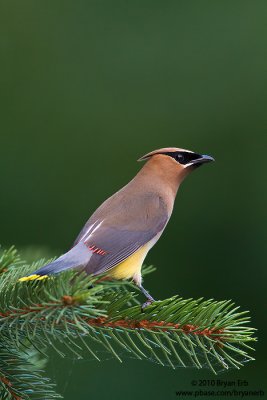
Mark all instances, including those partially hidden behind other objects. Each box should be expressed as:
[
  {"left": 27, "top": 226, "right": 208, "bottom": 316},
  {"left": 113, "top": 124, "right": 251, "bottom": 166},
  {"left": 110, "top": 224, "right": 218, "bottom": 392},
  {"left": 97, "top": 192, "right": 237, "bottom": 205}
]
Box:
[{"left": 107, "top": 243, "right": 151, "bottom": 279}]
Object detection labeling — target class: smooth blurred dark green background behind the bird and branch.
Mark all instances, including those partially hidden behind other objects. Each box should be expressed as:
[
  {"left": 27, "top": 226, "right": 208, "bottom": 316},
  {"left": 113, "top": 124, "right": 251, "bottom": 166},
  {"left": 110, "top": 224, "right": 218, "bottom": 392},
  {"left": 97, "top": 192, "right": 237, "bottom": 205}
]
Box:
[{"left": 0, "top": 0, "right": 267, "bottom": 400}]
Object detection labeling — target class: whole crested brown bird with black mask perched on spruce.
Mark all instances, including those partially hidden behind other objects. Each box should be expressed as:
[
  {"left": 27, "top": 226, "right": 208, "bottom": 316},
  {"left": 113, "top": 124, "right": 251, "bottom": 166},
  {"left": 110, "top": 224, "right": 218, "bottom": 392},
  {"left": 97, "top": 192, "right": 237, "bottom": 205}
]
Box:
[{"left": 19, "top": 147, "right": 214, "bottom": 309}]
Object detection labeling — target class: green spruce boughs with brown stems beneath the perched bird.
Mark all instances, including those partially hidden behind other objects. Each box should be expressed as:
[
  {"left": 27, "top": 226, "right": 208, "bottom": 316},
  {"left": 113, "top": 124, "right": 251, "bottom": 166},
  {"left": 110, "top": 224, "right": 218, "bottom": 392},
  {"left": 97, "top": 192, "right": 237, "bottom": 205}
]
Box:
[{"left": 0, "top": 245, "right": 256, "bottom": 399}]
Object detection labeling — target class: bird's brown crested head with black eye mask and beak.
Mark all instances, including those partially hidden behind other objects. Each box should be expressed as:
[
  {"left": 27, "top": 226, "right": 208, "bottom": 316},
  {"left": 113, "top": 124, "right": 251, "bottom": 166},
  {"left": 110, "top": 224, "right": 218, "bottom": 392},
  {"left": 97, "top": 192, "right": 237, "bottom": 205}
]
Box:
[{"left": 138, "top": 147, "right": 214, "bottom": 197}]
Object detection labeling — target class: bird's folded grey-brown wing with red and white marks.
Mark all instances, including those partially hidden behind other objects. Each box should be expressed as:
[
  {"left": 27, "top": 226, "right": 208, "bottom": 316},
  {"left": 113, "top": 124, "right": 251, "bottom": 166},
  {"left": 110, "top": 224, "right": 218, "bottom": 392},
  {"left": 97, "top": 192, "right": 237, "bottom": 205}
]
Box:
[{"left": 75, "top": 193, "right": 168, "bottom": 275}]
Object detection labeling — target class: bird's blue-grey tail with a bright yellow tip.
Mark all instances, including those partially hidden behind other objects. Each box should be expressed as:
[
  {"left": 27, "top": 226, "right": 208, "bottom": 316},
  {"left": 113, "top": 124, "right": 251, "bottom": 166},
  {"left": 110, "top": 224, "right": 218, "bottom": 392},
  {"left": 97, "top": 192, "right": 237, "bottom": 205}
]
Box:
[{"left": 19, "top": 242, "right": 93, "bottom": 282}]
